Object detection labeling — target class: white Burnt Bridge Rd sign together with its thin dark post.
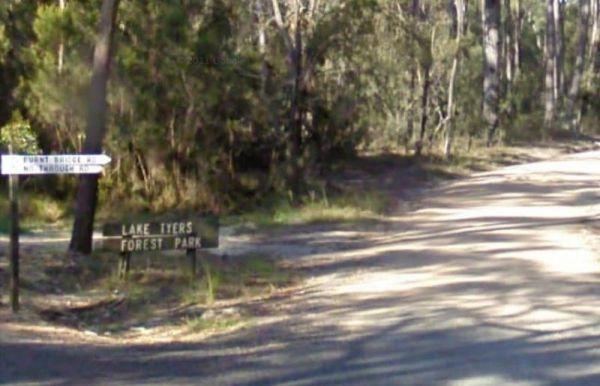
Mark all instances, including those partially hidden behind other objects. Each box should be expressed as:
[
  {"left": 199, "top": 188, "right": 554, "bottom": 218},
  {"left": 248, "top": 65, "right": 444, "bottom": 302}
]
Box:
[{"left": 1, "top": 152, "right": 110, "bottom": 312}]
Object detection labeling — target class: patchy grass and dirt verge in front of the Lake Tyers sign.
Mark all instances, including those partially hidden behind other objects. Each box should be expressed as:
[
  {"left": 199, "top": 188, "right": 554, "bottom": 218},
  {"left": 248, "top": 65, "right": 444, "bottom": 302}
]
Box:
[{"left": 28, "top": 254, "right": 301, "bottom": 335}]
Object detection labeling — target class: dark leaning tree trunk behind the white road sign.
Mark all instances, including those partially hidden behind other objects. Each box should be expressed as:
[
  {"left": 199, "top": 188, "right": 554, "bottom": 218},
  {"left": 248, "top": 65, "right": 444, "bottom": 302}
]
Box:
[{"left": 69, "top": 0, "right": 119, "bottom": 254}]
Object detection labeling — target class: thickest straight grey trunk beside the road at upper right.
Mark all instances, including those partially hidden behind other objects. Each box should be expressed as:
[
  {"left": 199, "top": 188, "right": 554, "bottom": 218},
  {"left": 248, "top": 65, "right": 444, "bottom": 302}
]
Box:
[{"left": 482, "top": 0, "right": 501, "bottom": 147}]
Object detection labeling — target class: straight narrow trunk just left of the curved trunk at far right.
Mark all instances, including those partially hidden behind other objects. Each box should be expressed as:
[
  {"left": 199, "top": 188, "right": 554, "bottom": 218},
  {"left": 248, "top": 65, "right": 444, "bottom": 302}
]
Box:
[{"left": 544, "top": 0, "right": 556, "bottom": 129}]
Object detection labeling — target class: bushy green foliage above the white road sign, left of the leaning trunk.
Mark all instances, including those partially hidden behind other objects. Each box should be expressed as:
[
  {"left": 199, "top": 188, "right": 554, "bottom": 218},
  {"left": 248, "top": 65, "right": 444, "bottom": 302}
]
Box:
[{"left": 23, "top": 2, "right": 97, "bottom": 152}]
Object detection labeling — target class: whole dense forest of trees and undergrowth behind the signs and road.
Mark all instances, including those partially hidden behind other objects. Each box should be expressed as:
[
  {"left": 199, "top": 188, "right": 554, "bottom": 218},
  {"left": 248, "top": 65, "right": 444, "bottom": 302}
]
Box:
[{"left": 0, "top": 0, "right": 600, "bottom": 255}]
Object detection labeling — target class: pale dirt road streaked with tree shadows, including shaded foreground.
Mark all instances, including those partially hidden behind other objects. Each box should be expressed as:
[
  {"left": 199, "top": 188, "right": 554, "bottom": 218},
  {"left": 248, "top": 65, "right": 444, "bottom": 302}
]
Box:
[{"left": 0, "top": 152, "right": 600, "bottom": 385}]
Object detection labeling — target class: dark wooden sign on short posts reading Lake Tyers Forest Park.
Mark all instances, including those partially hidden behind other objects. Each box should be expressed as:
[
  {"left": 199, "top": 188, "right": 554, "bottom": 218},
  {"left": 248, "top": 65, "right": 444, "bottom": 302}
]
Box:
[{"left": 102, "top": 215, "right": 219, "bottom": 277}]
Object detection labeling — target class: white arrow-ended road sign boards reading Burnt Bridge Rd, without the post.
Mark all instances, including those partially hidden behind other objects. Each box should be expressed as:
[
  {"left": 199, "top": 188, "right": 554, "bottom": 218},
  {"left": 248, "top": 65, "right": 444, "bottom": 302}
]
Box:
[{"left": 2, "top": 154, "right": 110, "bottom": 175}]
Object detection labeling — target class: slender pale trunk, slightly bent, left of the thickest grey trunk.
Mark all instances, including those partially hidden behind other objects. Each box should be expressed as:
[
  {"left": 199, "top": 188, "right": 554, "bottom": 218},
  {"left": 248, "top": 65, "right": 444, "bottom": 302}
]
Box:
[{"left": 444, "top": 0, "right": 465, "bottom": 158}]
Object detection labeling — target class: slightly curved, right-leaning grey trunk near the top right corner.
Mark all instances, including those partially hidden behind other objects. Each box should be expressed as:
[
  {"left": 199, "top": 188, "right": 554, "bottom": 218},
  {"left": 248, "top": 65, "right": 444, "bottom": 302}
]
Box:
[{"left": 565, "top": 0, "right": 590, "bottom": 135}]
